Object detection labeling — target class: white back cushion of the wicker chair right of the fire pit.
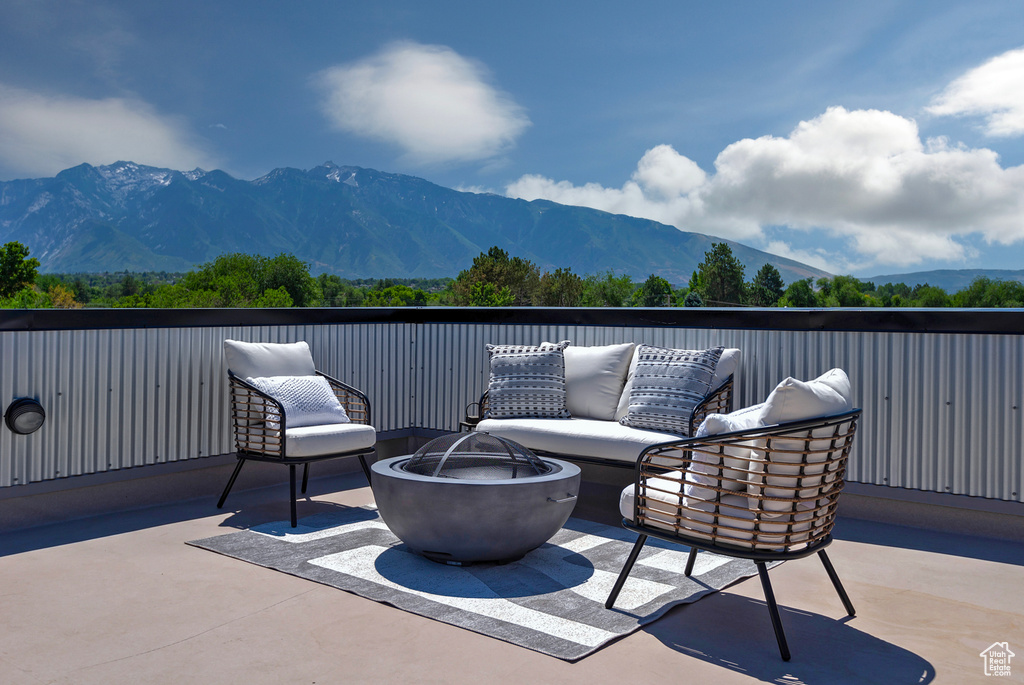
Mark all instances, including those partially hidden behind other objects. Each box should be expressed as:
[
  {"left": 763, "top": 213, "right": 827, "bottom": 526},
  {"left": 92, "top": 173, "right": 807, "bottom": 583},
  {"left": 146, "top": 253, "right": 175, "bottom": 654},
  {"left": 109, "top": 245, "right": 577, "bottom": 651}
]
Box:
[{"left": 748, "top": 369, "right": 853, "bottom": 515}]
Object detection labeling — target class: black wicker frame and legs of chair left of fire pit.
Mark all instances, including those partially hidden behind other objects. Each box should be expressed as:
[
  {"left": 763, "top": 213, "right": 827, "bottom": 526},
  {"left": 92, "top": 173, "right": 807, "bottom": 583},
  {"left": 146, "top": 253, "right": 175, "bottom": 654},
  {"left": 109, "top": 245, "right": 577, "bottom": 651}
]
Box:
[{"left": 217, "top": 371, "right": 376, "bottom": 528}]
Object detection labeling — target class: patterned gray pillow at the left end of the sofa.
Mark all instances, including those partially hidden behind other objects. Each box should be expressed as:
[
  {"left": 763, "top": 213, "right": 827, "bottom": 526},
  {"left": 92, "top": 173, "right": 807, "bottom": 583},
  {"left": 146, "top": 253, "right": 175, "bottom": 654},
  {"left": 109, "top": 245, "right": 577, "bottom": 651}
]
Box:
[{"left": 486, "top": 340, "right": 569, "bottom": 419}]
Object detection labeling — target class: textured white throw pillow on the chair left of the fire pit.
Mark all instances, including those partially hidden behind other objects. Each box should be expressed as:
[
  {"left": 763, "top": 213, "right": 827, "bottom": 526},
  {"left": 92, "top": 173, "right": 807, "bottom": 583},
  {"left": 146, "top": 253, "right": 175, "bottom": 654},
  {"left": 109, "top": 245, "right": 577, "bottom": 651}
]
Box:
[{"left": 246, "top": 376, "right": 350, "bottom": 429}]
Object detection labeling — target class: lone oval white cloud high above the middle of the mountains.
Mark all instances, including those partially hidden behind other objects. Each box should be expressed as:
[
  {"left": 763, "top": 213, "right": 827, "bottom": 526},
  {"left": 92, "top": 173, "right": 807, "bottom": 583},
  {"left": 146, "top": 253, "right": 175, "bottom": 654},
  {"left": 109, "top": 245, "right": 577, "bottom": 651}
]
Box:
[{"left": 315, "top": 42, "right": 529, "bottom": 163}]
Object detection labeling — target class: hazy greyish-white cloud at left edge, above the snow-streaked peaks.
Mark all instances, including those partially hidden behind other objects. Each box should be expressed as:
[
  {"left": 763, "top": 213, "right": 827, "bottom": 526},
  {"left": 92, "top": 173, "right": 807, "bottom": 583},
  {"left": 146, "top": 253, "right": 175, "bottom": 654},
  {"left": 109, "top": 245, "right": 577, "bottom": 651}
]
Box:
[{"left": 0, "top": 84, "right": 216, "bottom": 176}]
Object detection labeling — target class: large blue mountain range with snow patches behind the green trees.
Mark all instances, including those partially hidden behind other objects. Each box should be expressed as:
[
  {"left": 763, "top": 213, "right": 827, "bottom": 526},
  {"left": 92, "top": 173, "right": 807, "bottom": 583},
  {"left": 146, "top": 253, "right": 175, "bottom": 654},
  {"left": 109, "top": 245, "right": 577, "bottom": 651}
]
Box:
[{"left": 0, "top": 162, "right": 828, "bottom": 285}]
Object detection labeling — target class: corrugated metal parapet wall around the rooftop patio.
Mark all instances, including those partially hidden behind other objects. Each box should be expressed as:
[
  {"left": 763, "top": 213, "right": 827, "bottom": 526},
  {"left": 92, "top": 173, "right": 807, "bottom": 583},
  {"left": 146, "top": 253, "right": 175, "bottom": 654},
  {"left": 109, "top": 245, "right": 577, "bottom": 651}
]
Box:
[{"left": 0, "top": 310, "right": 1024, "bottom": 502}]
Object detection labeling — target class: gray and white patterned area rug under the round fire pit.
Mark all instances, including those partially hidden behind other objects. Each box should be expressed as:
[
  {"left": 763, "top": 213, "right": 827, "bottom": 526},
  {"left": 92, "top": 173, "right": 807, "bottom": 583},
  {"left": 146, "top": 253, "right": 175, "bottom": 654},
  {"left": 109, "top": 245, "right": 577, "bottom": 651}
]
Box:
[{"left": 188, "top": 507, "right": 757, "bottom": 661}]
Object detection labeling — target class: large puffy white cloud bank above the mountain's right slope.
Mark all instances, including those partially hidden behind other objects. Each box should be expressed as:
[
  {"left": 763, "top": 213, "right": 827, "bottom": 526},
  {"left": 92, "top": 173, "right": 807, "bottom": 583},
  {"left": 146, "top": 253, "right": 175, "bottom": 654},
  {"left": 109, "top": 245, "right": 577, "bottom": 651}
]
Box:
[{"left": 506, "top": 106, "right": 1024, "bottom": 272}]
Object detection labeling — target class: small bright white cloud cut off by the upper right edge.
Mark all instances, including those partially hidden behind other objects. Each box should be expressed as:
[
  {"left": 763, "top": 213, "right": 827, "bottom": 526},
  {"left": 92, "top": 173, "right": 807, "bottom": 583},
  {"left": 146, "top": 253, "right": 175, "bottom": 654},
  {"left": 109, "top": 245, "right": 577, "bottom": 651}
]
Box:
[{"left": 928, "top": 48, "right": 1024, "bottom": 136}]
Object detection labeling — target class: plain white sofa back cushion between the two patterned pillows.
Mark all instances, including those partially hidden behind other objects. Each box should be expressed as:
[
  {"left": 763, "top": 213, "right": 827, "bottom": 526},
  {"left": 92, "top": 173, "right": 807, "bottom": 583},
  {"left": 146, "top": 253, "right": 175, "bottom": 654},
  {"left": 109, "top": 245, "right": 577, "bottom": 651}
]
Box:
[{"left": 563, "top": 343, "right": 636, "bottom": 421}]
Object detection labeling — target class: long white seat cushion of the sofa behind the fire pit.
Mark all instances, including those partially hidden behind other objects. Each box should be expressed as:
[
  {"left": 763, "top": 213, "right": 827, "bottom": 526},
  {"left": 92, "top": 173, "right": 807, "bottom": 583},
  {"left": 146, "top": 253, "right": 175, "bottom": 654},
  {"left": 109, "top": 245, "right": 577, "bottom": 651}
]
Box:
[{"left": 476, "top": 419, "right": 680, "bottom": 463}]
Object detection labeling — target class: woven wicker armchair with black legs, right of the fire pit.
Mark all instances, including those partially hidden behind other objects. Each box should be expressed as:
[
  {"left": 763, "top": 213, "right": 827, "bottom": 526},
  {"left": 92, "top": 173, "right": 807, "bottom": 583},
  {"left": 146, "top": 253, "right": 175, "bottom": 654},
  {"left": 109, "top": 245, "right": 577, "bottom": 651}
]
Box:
[{"left": 605, "top": 410, "right": 860, "bottom": 660}]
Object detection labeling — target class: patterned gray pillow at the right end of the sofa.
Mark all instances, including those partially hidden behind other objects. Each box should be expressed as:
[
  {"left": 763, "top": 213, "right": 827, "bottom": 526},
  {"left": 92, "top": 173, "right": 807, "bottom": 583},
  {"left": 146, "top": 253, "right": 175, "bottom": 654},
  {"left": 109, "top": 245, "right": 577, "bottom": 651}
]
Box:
[{"left": 618, "top": 345, "right": 722, "bottom": 435}]
